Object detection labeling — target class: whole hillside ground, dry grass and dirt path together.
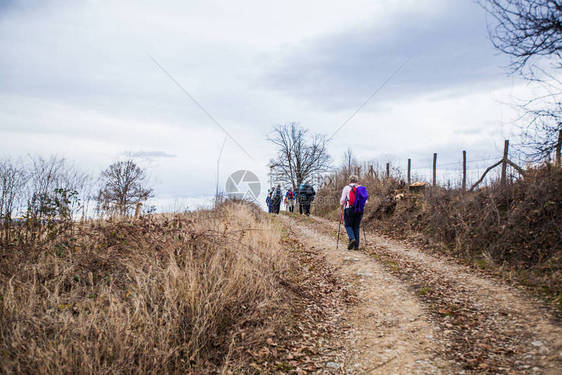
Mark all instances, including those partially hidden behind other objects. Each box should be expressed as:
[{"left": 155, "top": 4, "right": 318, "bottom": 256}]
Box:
[{"left": 0, "top": 202, "right": 562, "bottom": 375}]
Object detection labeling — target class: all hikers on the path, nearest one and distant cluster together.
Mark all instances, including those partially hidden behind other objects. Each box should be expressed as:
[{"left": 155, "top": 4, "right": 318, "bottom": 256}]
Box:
[{"left": 265, "top": 175, "right": 369, "bottom": 250}]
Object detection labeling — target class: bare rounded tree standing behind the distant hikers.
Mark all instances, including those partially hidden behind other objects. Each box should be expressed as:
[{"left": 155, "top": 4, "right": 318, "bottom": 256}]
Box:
[{"left": 268, "top": 122, "right": 330, "bottom": 188}]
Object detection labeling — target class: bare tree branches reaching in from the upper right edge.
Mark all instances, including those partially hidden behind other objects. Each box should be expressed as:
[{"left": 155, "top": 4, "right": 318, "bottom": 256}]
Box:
[{"left": 478, "top": 0, "right": 562, "bottom": 160}]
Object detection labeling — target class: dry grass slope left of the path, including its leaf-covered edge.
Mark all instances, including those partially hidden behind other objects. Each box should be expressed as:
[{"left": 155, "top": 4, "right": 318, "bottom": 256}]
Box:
[{"left": 0, "top": 201, "right": 353, "bottom": 375}]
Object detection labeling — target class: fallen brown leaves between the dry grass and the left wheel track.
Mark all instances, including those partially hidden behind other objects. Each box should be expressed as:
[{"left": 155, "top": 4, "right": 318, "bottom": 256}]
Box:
[{"left": 223, "top": 228, "right": 354, "bottom": 374}]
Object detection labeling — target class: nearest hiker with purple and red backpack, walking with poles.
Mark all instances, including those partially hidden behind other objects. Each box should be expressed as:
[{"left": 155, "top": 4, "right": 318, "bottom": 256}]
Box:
[{"left": 340, "top": 175, "right": 369, "bottom": 250}]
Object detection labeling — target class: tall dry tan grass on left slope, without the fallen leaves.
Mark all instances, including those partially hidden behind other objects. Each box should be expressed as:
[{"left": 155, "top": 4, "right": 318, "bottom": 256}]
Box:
[{"left": 0, "top": 203, "right": 287, "bottom": 374}]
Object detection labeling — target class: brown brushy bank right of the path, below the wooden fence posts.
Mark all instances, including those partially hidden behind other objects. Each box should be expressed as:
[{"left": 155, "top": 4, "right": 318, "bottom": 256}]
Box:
[{"left": 316, "top": 165, "right": 562, "bottom": 308}]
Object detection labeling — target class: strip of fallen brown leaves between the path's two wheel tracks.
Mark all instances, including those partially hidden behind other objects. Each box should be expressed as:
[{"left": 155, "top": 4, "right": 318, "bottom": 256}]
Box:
[{"left": 360, "top": 247, "right": 544, "bottom": 374}]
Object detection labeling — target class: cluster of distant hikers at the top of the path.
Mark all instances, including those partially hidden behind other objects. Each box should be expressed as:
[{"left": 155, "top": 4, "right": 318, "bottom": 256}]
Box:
[{"left": 265, "top": 184, "right": 316, "bottom": 215}]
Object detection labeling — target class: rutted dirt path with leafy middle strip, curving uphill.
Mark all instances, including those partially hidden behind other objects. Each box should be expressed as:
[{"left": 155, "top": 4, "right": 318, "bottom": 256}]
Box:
[{"left": 283, "top": 215, "right": 562, "bottom": 375}]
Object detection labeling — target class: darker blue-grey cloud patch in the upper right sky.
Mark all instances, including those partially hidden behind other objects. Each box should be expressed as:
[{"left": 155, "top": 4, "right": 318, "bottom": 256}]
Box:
[{"left": 264, "top": 0, "right": 506, "bottom": 109}]
